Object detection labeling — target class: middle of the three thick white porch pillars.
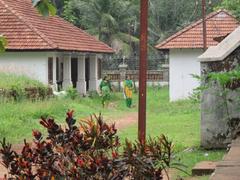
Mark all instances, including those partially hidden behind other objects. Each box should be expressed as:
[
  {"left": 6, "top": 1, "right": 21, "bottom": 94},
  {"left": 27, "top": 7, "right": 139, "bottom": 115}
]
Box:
[{"left": 77, "top": 55, "right": 87, "bottom": 95}]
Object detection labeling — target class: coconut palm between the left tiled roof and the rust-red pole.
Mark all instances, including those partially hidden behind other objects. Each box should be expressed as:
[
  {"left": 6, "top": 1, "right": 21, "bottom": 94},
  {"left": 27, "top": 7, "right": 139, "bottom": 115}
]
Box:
[{"left": 63, "top": 0, "right": 138, "bottom": 56}]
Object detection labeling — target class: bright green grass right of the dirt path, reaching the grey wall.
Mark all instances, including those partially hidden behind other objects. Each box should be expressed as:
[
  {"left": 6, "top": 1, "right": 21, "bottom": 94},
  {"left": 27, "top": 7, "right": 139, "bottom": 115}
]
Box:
[{"left": 119, "top": 87, "right": 225, "bottom": 176}]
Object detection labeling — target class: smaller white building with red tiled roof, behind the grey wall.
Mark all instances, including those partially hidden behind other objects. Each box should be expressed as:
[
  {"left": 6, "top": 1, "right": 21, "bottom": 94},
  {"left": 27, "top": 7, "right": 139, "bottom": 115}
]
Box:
[{"left": 156, "top": 10, "right": 239, "bottom": 101}]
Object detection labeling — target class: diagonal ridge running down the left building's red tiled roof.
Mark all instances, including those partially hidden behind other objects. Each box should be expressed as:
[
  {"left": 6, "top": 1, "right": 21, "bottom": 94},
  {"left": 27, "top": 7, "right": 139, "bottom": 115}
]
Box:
[{"left": 0, "top": 0, "right": 58, "bottom": 49}]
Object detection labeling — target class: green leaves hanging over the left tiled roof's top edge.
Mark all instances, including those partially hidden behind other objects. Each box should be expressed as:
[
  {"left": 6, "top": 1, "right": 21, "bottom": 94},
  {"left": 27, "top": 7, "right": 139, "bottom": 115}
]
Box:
[{"left": 32, "top": 0, "right": 57, "bottom": 16}]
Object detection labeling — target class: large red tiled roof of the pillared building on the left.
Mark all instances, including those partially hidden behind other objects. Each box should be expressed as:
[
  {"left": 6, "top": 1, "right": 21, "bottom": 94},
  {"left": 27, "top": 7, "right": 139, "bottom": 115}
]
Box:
[{"left": 0, "top": 0, "right": 114, "bottom": 53}]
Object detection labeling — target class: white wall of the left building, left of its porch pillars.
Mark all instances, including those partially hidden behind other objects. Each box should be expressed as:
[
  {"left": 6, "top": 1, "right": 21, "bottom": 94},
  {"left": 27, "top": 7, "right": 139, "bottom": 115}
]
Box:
[{"left": 0, "top": 52, "right": 51, "bottom": 84}]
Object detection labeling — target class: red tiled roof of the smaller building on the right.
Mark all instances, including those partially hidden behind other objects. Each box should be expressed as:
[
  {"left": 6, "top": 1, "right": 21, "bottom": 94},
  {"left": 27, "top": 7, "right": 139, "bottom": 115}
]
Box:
[{"left": 156, "top": 10, "right": 239, "bottom": 49}]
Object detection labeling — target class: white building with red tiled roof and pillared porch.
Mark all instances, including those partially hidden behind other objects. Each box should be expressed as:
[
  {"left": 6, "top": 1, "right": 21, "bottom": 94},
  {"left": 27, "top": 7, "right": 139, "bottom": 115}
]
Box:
[{"left": 0, "top": 0, "right": 114, "bottom": 94}]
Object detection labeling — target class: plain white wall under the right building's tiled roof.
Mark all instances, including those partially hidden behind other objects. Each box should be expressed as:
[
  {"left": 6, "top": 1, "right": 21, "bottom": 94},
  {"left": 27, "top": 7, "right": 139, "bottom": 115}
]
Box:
[{"left": 169, "top": 49, "right": 203, "bottom": 101}]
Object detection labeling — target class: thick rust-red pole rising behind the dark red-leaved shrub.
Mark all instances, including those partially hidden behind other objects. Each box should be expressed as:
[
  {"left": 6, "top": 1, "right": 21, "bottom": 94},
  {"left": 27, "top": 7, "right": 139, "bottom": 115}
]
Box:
[{"left": 138, "top": 0, "right": 148, "bottom": 143}]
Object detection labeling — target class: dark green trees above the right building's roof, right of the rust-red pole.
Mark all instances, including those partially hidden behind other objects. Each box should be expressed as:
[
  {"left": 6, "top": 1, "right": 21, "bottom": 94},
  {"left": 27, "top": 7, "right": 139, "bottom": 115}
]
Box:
[{"left": 149, "top": 0, "right": 220, "bottom": 44}]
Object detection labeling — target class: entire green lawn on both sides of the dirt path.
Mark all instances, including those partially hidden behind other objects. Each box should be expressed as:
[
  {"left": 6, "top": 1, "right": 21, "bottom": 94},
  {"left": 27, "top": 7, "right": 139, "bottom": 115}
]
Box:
[{"left": 0, "top": 87, "right": 224, "bottom": 179}]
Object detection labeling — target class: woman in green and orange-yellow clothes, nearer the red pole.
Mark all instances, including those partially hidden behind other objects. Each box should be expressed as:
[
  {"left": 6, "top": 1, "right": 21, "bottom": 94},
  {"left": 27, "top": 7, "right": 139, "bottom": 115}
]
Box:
[{"left": 123, "top": 76, "right": 133, "bottom": 108}]
